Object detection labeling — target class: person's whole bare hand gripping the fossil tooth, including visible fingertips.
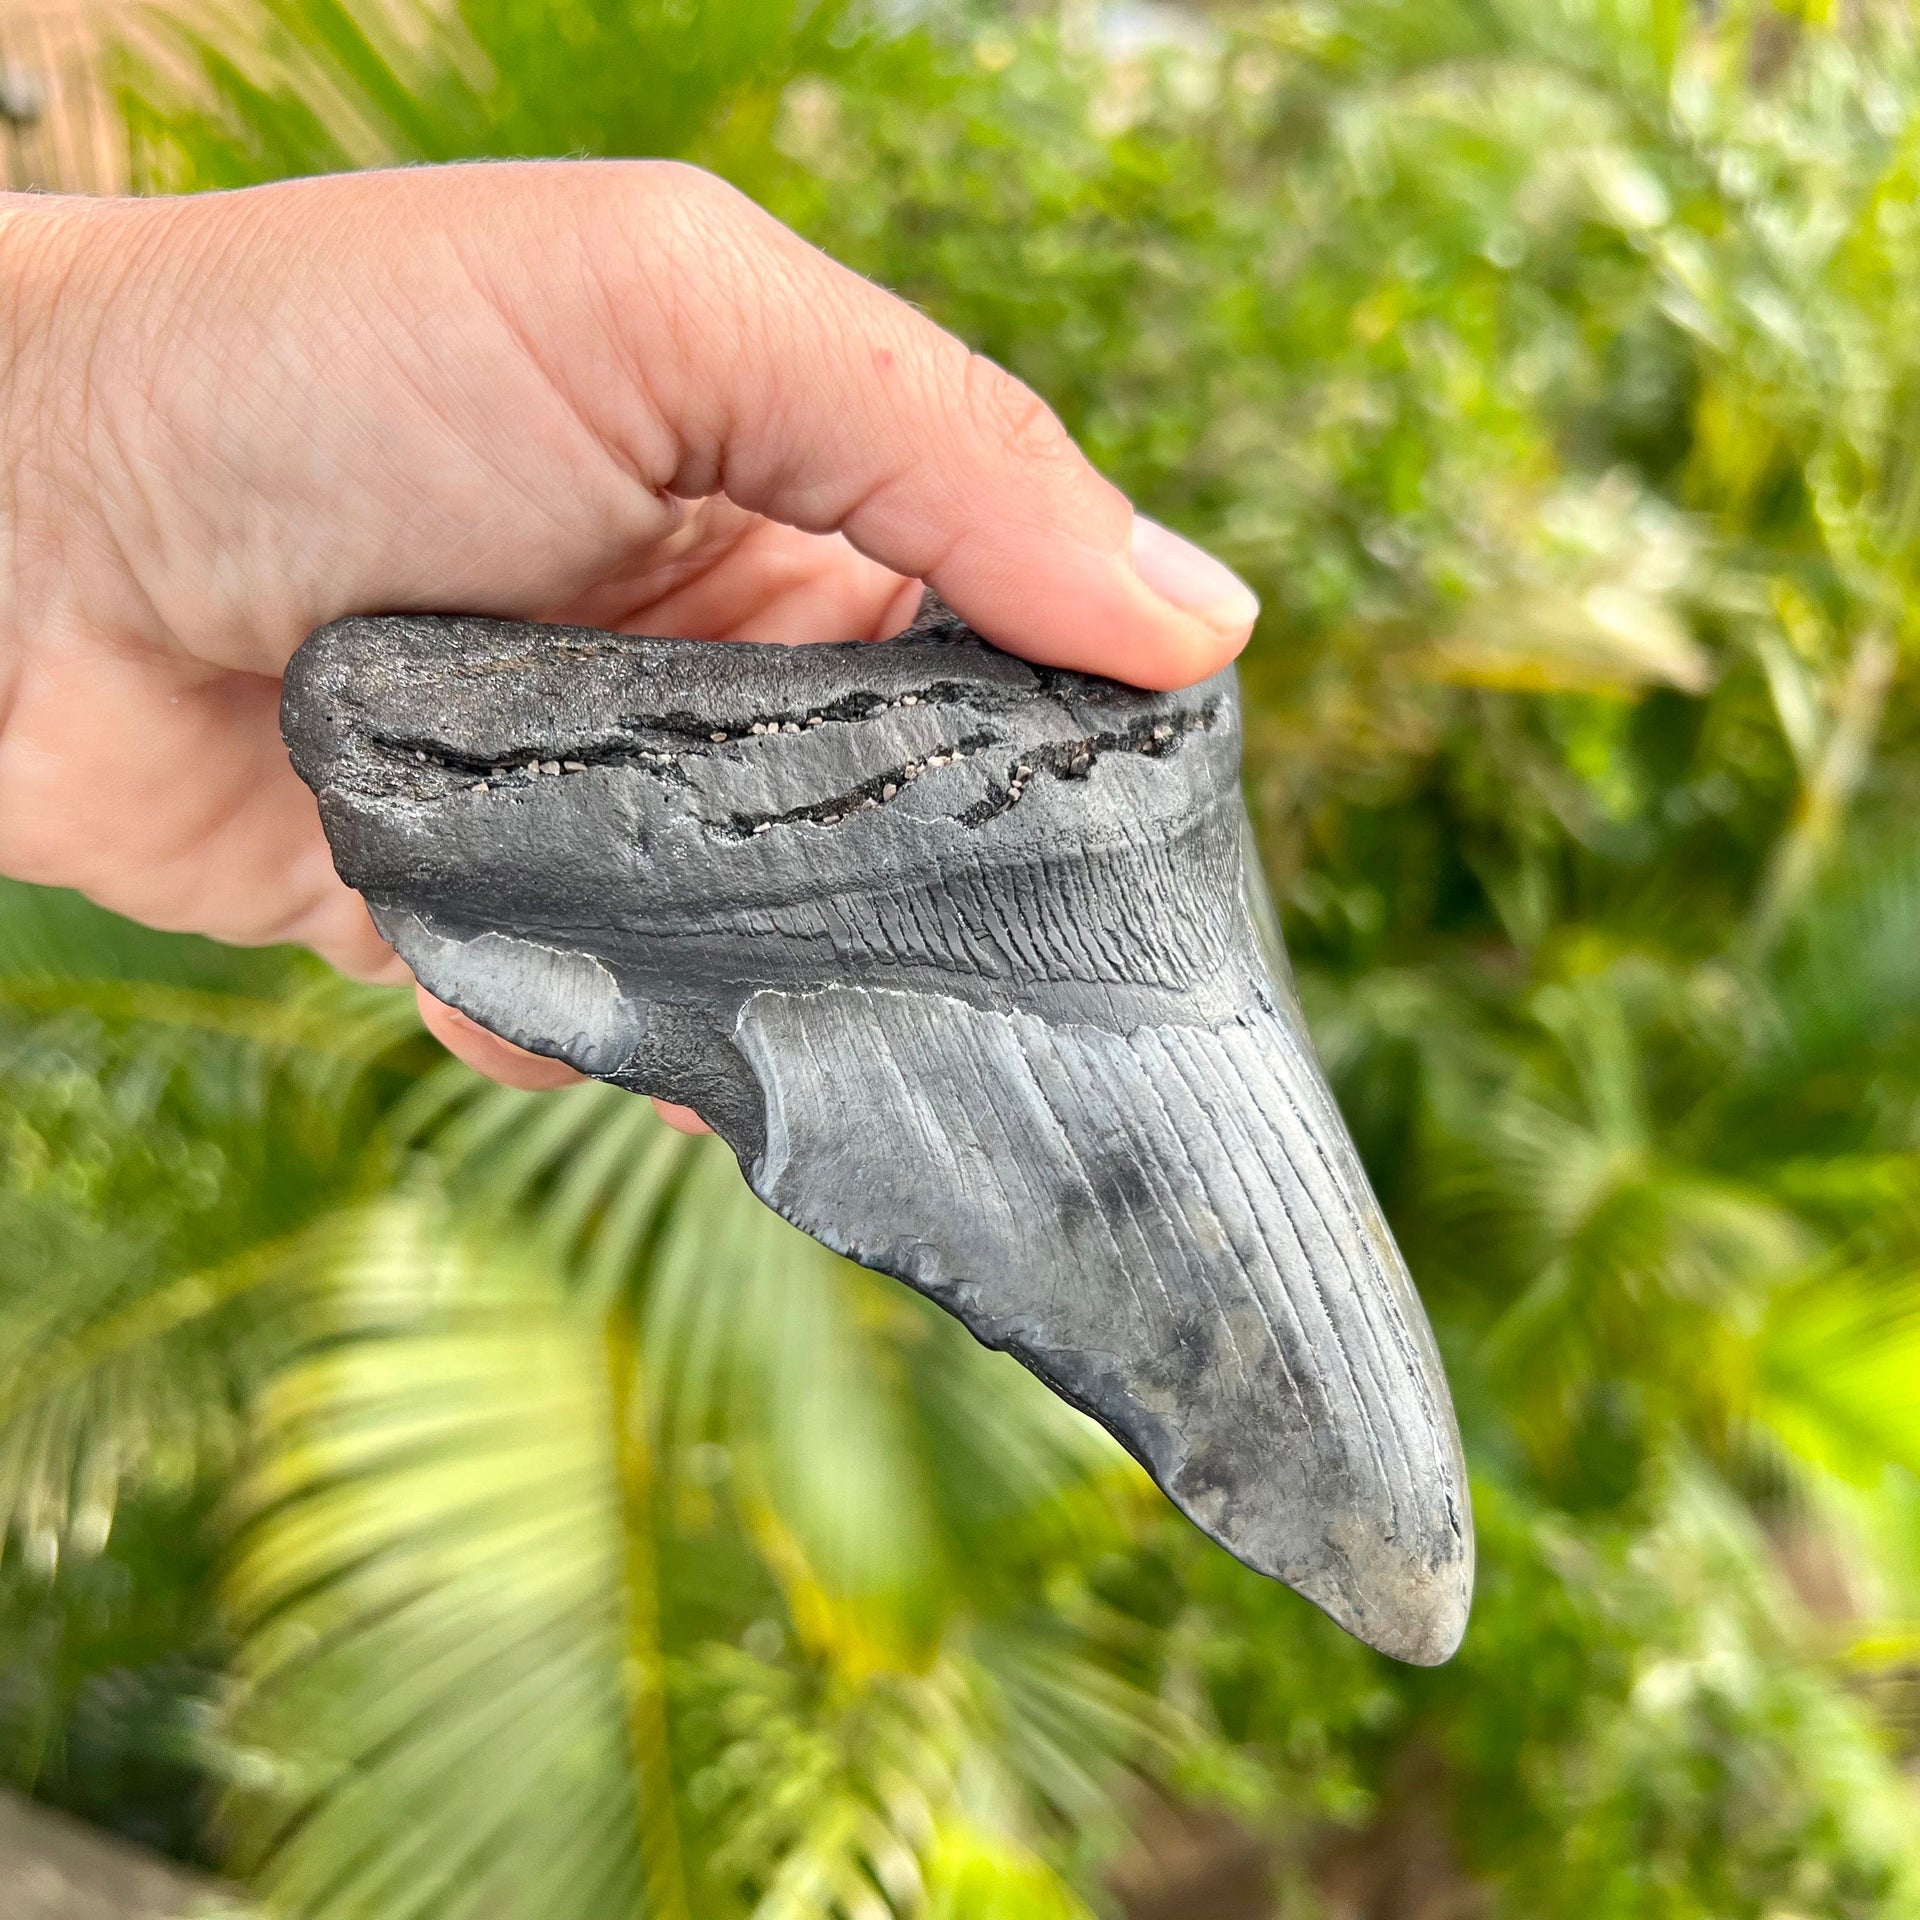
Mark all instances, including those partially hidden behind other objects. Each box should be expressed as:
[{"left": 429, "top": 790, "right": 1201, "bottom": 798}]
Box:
[{"left": 0, "top": 161, "right": 1258, "bottom": 1127}]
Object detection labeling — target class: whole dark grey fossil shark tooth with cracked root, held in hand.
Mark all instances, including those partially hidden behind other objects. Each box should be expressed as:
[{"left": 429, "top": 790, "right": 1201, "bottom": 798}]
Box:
[{"left": 282, "top": 605, "right": 1473, "bottom": 1663}]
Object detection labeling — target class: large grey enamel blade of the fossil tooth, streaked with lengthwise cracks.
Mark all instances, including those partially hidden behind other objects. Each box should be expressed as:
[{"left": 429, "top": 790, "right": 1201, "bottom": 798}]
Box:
[{"left": 739, "top": 987, "right": 1471, "bottom": 1661}]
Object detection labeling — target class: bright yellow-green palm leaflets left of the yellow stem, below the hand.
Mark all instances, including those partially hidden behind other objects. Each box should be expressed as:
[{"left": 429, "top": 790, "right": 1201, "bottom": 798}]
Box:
[{"left": 228, "top": 1200, "right": 660, "bottom": 1920}]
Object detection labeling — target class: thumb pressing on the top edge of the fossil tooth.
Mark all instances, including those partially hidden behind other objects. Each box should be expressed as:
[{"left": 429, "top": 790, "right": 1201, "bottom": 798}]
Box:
[{"left": 624, "top": 167, "right": 1260, "bottom": 689}]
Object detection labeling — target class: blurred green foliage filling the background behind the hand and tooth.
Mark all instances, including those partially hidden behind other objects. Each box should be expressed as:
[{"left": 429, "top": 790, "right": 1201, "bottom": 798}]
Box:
[{"left": 0, "top": 0, "right": 1920, "bottom": 1920}]
